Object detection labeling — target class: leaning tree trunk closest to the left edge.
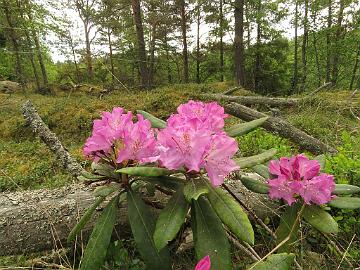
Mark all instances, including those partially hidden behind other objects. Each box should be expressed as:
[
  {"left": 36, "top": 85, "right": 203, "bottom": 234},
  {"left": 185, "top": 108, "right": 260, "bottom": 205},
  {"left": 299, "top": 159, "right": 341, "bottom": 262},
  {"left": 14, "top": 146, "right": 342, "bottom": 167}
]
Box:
[{"left": 2, "top": 0, "right": 25, "bottom": 86}]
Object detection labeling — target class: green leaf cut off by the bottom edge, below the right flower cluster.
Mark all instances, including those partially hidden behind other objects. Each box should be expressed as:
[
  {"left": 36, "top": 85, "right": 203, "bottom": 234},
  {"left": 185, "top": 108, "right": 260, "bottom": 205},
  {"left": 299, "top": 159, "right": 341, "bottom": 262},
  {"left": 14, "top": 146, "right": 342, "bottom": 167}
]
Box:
[{"left": 249, "top": 253, "right": 295, "bottom": 270}]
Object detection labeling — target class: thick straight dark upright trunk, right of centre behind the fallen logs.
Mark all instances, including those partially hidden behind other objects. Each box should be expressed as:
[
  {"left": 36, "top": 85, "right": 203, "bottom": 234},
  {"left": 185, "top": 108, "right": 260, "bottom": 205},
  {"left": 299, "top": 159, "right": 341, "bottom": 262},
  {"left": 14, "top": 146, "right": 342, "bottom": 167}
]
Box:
[{"left": 234, "top": 0, "right": 246, "bottom": 87}]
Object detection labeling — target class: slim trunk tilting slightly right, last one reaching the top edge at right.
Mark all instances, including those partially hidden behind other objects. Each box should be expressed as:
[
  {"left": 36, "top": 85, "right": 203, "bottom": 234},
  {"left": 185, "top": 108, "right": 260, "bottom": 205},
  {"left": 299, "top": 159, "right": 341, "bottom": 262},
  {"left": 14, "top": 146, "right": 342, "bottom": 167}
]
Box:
[{"left": 331, "top": 0, "right": 345, "bottom": 85}]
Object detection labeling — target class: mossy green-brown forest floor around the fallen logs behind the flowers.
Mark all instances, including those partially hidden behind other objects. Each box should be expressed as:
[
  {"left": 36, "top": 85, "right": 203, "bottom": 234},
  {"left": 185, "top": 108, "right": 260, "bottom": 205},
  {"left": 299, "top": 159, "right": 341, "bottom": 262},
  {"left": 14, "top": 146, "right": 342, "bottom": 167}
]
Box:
[{"left": 0, "top": 83, "right": 360, "bottom": 269}]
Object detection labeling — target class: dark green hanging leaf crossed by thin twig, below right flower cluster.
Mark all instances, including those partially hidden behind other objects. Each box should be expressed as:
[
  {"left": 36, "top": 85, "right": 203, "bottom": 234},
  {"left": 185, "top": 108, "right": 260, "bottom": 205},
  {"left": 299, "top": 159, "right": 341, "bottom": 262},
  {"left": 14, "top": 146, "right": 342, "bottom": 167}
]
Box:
[{"left": 275, "top": 203, "right": 301, "bottom": 253}]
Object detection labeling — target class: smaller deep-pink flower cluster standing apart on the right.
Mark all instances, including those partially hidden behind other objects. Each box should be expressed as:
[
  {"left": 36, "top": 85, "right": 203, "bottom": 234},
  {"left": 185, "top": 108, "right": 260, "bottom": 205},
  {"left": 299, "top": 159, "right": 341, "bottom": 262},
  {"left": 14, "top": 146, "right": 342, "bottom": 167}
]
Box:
[{"left": 268, "top": 154, "right": 335, "bottom": 205}]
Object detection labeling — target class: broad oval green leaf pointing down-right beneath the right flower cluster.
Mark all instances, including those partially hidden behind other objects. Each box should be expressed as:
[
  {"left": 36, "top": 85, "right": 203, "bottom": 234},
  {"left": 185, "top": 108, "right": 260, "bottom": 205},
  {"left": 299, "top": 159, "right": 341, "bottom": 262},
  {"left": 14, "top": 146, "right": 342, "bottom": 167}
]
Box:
[{"left": 302, "top": 205, "right": 339, "bottom": 233}]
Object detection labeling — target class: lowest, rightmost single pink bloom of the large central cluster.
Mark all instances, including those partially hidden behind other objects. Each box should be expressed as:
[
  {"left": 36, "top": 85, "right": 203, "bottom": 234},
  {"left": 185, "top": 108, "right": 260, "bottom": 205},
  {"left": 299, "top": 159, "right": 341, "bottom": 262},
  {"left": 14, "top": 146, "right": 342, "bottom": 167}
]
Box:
[{"left": 204, "top": 133, "right": 240, "bottom": 186}]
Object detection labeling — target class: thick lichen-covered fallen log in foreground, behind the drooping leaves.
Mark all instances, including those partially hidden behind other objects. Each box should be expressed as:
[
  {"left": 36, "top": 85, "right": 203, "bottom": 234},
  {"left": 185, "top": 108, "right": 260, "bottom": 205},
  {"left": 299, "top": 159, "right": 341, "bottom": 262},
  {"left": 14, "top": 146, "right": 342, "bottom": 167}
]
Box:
[{"left": 0, "top": 178, "right": 276, "bottom": 256}]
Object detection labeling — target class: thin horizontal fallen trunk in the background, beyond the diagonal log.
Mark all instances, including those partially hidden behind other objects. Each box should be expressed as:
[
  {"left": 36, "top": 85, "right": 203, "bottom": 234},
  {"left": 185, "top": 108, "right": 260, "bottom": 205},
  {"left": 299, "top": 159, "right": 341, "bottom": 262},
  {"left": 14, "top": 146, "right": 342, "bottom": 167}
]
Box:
[{"left": 201, "top": 94, "right": 300, "bottom": 106}]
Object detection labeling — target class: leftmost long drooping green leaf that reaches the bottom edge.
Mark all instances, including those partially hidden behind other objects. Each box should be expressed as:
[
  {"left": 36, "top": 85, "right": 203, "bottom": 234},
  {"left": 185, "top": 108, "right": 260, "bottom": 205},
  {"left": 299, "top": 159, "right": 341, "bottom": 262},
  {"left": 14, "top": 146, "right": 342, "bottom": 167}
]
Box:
[{"left": 80, "top": 196, "right": 118, "bottom": 270}]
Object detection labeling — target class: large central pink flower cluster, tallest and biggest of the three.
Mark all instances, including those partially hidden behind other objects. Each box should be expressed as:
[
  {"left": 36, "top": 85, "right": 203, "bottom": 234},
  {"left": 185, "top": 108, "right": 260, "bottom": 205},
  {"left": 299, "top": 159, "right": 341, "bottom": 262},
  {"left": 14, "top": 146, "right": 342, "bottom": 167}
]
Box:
[{"left": 157, "top": 101, "right": 239, "bottom": 186}]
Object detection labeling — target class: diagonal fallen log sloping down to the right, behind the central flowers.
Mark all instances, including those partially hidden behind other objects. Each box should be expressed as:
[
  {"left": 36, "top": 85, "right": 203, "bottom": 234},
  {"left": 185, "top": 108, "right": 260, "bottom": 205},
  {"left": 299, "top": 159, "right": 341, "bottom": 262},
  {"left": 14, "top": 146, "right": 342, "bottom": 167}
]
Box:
[{"left": 224, "top": 102, "right": 337, "bottom": 155}]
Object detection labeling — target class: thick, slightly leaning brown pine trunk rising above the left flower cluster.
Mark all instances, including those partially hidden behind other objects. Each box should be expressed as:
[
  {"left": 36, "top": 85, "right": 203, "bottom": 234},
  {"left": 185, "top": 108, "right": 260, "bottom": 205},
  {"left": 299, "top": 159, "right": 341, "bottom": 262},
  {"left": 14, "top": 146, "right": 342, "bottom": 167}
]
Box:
[{"left": 131, "top": 0, "right": 149, "bottom": 88}]
